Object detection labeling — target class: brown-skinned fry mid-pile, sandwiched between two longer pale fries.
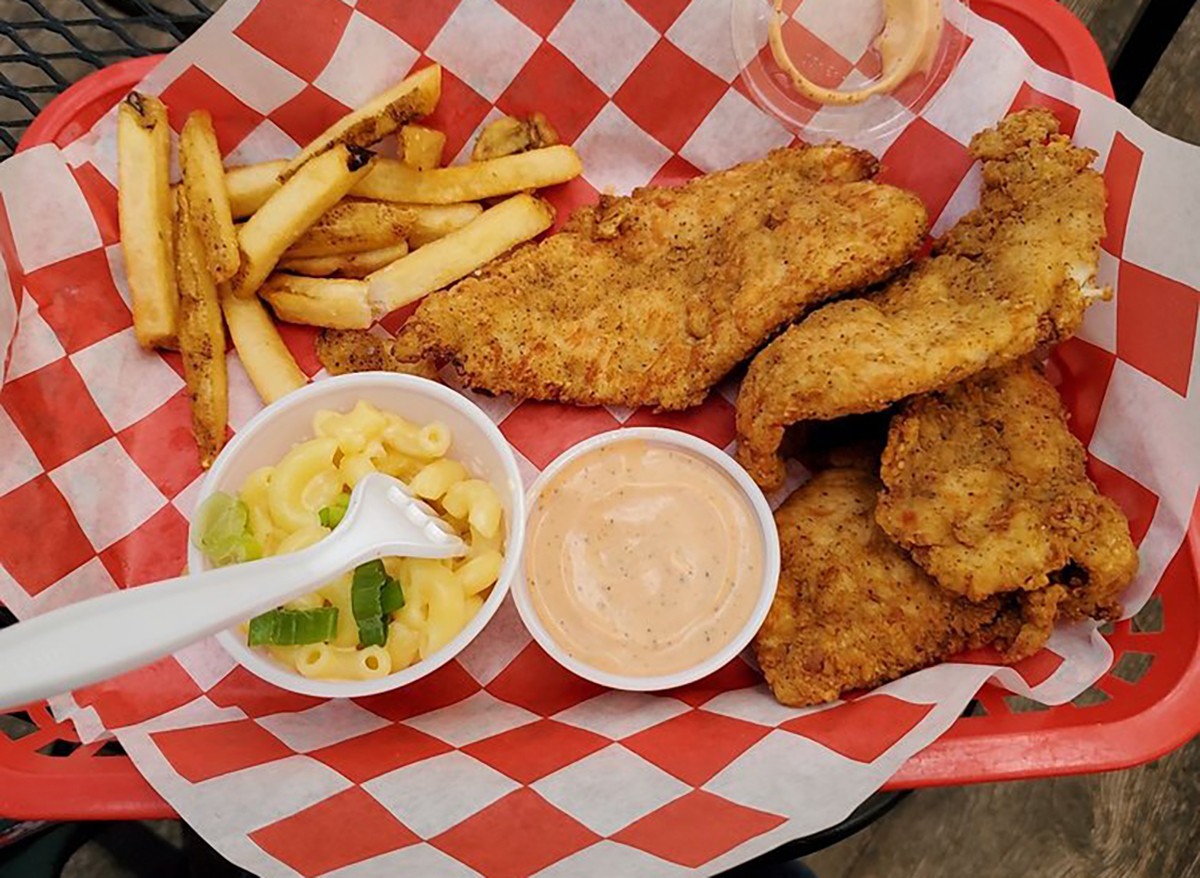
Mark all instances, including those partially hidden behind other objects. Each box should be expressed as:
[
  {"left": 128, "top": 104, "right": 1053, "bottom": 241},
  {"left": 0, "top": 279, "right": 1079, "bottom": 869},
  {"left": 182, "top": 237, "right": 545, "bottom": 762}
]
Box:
[{"left": 283, "top": 200, "right": 484, "bottom": 259}]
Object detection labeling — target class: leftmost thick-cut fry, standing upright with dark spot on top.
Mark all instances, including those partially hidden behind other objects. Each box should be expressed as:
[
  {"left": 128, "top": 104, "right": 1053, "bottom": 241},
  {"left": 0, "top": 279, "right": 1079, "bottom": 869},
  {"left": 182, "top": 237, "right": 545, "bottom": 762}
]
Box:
[{"left": 116, "top": 91, "right": 179, "bottom": 348}]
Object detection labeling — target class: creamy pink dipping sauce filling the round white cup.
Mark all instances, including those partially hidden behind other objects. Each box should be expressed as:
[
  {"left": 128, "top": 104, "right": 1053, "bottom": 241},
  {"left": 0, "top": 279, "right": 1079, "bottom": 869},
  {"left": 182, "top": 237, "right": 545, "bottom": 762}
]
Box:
[{"left": 526, "top": 439, "right": 763, "bottom": 676}]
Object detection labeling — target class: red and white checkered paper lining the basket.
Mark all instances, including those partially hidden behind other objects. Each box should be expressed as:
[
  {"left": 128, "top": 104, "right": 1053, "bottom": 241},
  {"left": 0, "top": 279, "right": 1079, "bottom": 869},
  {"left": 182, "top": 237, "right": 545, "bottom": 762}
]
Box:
[{"left": 0, "top": 0, "right": 1200, "bottom": 878}]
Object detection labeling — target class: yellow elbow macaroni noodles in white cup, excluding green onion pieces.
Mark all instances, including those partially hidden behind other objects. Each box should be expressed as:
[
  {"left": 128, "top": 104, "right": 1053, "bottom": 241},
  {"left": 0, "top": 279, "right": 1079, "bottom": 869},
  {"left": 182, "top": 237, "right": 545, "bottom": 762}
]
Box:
[{"left": 240, "top": 402, "right": 504, "bottom": 680}]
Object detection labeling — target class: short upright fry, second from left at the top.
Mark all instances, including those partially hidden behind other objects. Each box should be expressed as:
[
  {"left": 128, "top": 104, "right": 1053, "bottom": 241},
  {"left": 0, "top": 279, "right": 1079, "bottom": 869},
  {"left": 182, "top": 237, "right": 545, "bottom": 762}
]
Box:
[{"left": 179, "top": 110, "right": 241, "bottom": 283}]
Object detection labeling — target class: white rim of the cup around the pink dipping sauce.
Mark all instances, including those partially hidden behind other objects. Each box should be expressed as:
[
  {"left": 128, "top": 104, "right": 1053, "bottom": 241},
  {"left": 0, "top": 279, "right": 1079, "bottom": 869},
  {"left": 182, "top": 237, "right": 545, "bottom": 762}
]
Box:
[{"left": 512, "top": 427, "right": 780, "bottom": 692}]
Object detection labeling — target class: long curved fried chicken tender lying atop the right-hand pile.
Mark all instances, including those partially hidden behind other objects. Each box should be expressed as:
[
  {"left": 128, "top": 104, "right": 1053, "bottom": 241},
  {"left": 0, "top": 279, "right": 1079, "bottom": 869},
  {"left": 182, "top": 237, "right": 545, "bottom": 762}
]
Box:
[{"left": 738, "top": 109, "right": 1109, "bottom": 489}]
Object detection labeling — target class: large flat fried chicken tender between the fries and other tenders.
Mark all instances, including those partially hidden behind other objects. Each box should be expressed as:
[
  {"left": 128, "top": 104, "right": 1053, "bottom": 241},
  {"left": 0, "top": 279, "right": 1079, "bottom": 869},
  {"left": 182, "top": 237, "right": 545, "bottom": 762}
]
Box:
[{"left": 402, "top": 145, "right": 928, "bottom": 409}]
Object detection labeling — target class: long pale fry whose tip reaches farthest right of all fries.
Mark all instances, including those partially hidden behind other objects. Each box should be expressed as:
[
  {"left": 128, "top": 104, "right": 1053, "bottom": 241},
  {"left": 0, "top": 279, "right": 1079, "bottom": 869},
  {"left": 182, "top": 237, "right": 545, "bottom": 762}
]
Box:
[{"left": 354, "top": 145, "right": 583, "bottom": 204}]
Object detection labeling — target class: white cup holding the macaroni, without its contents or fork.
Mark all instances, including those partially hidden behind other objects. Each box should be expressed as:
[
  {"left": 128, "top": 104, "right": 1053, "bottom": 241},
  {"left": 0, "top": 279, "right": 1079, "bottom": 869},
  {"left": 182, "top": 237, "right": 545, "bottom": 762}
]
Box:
[{"left": 187, "top": 372, "right": 526, "bottom": 698}]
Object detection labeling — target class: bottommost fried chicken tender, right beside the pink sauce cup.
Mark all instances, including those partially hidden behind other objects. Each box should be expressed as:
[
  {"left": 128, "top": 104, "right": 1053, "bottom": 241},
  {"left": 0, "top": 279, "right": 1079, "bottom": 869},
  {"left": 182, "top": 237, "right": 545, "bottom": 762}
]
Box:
[{"left": 754, "top": 458, "right": 1022, "bottom": 706}]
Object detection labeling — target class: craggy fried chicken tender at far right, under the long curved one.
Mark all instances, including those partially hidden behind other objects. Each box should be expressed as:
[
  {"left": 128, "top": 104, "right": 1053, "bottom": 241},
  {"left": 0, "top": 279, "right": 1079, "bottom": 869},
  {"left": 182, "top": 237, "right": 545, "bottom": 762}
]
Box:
[{"left": 875, "top": 359, "right": 1138, "bottom": 624}]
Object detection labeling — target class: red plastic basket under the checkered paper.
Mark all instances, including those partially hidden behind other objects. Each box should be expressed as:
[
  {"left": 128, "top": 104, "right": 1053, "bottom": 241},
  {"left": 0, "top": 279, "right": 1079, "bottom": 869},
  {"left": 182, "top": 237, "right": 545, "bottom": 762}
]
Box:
[{"left": 0, "top": 0, "right": 1200, "bottom": 819}]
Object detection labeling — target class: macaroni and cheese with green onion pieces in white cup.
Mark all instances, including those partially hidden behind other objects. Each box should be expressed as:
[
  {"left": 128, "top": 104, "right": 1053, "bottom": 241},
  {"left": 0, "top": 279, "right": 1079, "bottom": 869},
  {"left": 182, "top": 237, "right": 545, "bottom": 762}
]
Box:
[{"left": 200, "top": 402, "right": 504, "bottom": 680}]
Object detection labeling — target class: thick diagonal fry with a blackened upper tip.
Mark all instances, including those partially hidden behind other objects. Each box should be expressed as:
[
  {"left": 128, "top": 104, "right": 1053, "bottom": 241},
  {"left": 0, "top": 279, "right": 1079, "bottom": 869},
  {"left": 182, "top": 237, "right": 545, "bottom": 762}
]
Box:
[{"left": 232, "top": 144, "right": 374, "bottom": 302}]
